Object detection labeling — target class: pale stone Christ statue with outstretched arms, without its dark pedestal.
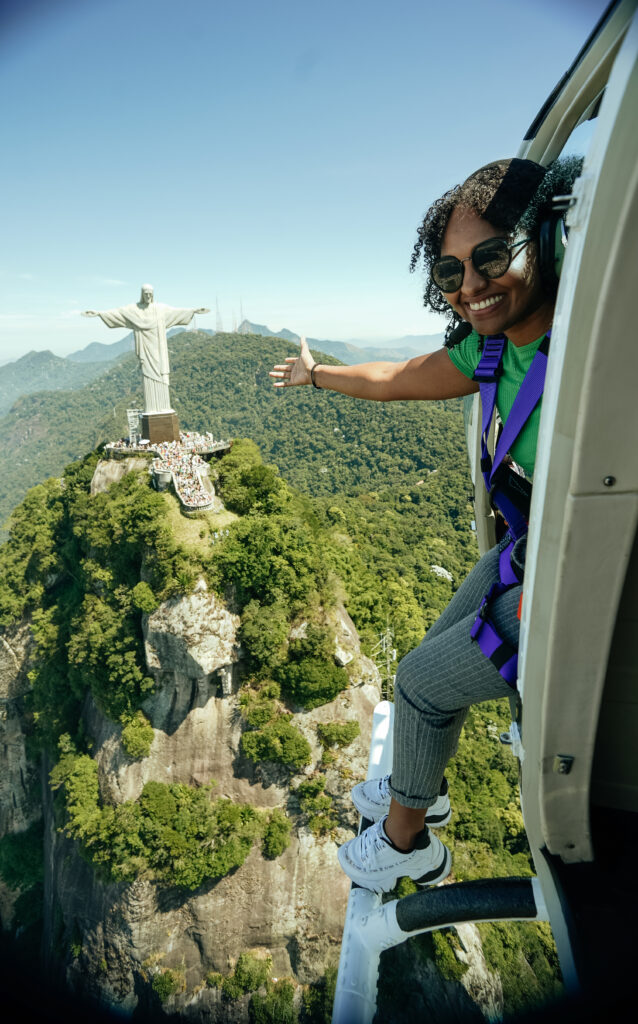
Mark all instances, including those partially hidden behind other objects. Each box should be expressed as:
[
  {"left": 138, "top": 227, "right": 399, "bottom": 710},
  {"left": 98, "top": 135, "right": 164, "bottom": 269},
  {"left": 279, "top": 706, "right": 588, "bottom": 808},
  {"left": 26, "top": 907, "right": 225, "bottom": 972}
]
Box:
[{"left": 82, "top": 285, "right": 210, "bottom": 417}]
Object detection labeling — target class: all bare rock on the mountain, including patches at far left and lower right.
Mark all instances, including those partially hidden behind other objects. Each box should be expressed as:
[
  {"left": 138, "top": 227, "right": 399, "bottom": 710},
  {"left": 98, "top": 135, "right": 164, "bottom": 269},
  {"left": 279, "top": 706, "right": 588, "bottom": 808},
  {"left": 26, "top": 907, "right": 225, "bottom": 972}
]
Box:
[{"left": 0, "top": 460, "right": 514, "bottom": 1024}]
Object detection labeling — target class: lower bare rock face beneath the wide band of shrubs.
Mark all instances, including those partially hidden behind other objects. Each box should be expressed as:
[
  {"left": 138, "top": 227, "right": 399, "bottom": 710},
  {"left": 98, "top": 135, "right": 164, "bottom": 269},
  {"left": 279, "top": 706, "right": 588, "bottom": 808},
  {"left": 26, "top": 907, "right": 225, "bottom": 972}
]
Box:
[{"left": 52, "top": 716, "right": 362, "bottom": 1019}]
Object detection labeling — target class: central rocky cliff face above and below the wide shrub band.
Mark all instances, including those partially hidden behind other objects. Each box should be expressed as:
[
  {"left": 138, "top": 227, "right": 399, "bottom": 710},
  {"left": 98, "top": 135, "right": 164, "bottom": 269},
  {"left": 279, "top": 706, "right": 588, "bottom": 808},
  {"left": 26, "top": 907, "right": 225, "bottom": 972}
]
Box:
[{"left": 46, "top": 586, "right": 379, "bottom": 1021}]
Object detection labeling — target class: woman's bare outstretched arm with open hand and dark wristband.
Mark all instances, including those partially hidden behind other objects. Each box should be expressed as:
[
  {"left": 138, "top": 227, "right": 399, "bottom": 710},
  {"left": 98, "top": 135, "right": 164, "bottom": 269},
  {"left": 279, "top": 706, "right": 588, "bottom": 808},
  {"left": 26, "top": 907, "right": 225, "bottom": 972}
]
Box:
[{"left": 270, "top": 338, "right": 478, "bottom": 401}]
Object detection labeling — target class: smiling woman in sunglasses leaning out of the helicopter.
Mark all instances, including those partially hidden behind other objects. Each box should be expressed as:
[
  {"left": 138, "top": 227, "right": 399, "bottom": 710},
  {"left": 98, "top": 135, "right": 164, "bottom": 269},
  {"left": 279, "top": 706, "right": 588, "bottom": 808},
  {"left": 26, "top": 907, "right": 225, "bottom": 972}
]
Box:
[{"left": 270, "top": 158, "right": 581, "bottom": 892}]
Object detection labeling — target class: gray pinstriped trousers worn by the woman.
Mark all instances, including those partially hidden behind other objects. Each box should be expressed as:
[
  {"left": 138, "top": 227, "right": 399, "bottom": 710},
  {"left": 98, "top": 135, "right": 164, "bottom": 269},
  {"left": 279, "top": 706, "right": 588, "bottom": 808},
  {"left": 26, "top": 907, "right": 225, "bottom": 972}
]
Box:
[{"left": 390, "top": 541, "right": 522, "bottom": 808}]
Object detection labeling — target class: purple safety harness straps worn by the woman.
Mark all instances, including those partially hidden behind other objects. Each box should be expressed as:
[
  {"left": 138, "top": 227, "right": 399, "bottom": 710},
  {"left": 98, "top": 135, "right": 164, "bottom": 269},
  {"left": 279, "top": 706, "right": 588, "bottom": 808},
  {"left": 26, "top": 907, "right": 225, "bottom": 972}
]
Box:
[{"left": 470, "top": 331, "right": 551, "bottom": 687}]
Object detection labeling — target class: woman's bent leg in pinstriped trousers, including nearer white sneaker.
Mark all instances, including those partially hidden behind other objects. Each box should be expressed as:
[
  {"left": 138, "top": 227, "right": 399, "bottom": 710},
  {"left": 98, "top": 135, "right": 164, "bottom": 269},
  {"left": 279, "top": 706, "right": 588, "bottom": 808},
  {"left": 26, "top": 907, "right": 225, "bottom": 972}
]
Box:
[{"left": 338, "top": 549, "right": 521, "bottom": 892}]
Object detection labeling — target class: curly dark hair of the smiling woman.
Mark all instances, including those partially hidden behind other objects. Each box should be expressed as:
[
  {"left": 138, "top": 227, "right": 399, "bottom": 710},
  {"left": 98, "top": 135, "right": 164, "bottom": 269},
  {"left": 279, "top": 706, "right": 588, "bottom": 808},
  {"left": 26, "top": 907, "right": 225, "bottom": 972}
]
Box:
[{"left": 410, "top": 157, "right": 583, "bottom": 339}]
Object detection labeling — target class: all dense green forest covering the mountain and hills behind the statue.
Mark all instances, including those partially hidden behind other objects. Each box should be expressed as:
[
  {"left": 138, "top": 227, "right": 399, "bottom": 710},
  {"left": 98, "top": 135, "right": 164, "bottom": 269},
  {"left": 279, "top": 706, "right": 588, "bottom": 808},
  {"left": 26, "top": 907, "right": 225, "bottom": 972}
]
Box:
[{"left": 0, "top": 334, "right": 559, "bottom": 1019}]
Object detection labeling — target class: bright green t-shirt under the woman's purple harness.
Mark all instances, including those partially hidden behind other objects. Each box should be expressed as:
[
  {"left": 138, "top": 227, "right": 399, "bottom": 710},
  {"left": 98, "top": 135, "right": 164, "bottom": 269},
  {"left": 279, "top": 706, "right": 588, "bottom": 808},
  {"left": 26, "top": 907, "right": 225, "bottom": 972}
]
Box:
[{"left": 448, "top": 331, "right": 545, "bottom": 477}]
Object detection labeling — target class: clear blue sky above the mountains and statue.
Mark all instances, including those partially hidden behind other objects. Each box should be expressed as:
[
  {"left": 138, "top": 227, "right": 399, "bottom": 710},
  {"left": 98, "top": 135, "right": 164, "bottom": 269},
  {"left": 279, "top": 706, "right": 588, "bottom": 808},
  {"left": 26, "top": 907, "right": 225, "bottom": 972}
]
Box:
[{"left": 0, "top": 0, "right": 606, "bottom": 360}]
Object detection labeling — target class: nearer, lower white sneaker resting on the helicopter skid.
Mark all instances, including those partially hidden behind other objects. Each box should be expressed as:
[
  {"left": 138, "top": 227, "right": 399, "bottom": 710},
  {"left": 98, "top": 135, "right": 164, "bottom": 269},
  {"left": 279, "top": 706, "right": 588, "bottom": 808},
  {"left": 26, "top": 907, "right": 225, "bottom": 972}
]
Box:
[{"left": 337, "top": 815, "right": 452, "bottom": 893}]
